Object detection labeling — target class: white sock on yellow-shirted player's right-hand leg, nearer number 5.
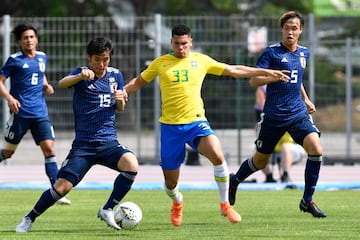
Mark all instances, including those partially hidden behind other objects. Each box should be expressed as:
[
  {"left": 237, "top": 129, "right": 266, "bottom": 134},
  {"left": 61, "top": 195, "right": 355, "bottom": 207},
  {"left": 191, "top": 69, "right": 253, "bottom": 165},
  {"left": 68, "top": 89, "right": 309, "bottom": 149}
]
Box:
[{"left": 214, "top": 161, "right": 229, "bottom": 203}]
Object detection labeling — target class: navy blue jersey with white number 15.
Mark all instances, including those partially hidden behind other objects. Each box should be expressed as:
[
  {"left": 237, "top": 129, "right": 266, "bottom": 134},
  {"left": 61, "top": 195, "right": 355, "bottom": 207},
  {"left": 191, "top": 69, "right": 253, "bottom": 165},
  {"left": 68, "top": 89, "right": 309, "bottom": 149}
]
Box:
[{"left": 68, "top": 67, "right": 124, "bottom": 142}]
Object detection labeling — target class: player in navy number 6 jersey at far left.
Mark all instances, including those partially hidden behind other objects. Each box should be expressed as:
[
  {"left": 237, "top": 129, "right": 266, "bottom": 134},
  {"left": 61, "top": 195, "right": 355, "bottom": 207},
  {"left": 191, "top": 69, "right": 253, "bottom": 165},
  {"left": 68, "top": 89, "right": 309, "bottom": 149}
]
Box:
[{"left": 0, "top": 24, "right": 71, "bottom": 204}]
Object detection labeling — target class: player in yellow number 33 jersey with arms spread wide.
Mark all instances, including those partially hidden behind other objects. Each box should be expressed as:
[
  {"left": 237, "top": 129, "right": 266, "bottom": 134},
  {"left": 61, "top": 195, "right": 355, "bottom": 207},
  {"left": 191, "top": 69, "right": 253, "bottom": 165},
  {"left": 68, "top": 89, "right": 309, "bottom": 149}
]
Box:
[{"left": 125, "top": 24, "right": 287, "bottom": 226}]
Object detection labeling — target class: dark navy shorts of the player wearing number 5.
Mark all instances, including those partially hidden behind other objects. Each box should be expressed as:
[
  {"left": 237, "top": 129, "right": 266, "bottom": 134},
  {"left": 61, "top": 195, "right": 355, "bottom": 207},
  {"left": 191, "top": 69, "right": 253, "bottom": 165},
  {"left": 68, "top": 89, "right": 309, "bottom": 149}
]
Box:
[{"left": 255, "top": 113, "right": 320, "bottom": 154}]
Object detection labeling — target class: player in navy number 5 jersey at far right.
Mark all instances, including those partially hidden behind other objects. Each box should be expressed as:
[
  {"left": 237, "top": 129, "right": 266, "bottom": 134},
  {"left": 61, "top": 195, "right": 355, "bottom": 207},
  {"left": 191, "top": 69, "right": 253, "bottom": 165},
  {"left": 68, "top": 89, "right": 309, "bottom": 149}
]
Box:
[{"left": 229, "top": 11, "right": 326, "bottom": 218}]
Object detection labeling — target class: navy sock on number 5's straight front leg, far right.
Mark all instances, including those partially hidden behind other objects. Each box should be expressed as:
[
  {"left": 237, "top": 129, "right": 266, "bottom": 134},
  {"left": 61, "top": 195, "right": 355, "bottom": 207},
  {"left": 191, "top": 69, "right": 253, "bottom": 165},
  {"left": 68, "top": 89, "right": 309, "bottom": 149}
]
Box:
[{"left": 303, "top": 156, "right": 321, "bottom": 202}]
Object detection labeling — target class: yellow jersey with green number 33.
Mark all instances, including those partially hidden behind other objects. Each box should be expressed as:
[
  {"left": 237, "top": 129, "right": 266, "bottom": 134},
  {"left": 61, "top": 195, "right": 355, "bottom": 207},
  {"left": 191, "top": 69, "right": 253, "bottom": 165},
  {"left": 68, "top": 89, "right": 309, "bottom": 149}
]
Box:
[{"left": 141, "top": 52, "right": 226, "bottom": 124}]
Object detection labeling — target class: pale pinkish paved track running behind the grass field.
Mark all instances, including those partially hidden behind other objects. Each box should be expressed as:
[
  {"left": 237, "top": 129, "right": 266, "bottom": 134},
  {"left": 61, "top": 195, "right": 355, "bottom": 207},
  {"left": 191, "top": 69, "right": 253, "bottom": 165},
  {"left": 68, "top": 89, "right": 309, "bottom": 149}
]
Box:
[{"left": 0, "top": 165, "right": 360, "bottom": 184}]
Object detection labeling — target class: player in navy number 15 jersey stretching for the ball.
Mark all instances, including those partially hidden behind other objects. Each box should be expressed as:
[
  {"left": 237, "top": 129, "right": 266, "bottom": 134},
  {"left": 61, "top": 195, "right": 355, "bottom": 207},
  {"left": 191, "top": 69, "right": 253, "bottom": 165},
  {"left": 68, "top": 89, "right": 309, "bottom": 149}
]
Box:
[{"left": 16, "top": 37, "right": 138, "bottom": 232}]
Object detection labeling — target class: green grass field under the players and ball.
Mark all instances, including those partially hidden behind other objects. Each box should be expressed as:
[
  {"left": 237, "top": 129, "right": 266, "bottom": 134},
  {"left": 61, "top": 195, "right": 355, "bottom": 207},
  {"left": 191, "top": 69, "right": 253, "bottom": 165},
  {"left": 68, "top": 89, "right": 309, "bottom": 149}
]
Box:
[{"left": 0, "top": 189, "right": 360, "bottom": 240}]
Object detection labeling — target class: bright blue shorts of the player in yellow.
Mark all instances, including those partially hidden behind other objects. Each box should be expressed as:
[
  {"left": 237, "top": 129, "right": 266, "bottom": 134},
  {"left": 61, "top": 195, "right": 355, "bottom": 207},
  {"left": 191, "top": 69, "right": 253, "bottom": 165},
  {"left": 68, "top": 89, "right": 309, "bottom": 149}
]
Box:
[{"left": 160, "top": 121, "right": 215, "bottom": 170}]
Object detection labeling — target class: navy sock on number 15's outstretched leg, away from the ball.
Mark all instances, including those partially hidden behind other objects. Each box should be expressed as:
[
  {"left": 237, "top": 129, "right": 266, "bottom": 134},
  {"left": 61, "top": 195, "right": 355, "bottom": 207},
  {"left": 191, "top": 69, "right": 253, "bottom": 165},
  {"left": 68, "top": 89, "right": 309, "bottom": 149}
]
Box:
[{"left": 26, "top": 188, "right": 62, "bottom": 222}]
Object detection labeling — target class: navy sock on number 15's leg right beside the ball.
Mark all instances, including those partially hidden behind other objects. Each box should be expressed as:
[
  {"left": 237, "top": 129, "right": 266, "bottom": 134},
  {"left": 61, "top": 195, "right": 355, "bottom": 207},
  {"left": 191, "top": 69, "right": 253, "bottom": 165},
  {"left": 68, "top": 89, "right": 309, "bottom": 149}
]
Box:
[{"left": 103, "top": 172, "right": 137, "bottom": 209}]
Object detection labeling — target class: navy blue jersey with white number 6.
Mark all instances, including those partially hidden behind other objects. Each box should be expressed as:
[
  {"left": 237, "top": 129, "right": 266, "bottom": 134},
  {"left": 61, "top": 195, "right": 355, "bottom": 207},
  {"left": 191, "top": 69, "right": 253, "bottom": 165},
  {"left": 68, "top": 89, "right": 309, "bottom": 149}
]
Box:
[{"left": 0, "top": 51, "right": 48, "bottom": 118}]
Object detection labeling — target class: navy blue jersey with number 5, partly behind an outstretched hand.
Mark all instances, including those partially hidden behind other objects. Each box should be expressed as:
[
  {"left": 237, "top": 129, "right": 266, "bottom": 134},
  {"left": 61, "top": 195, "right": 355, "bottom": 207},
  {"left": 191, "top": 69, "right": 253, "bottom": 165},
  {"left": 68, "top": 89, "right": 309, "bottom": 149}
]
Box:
[{"left": 256, "top": 43, "right": 310, "bottom": 121}]
